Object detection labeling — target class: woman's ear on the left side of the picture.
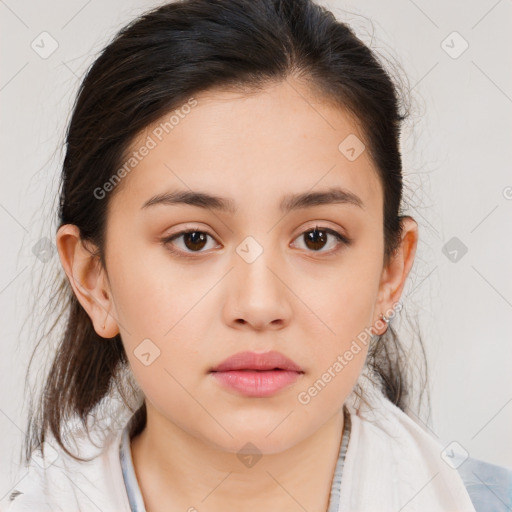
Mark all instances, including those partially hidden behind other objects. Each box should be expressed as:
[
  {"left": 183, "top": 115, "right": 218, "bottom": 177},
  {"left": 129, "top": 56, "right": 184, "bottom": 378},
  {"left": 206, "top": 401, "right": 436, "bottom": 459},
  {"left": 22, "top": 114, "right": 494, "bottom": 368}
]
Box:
[{"left": 56, "top": 224, "right": 119, "bottom": 338}]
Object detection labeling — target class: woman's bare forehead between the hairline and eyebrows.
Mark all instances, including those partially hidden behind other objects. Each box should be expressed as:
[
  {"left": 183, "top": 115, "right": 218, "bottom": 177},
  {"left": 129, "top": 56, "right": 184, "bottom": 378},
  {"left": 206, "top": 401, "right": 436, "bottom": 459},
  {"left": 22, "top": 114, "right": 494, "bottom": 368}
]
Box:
[{"left": 110, "top": 80, "right": 382, "bottom": 218}]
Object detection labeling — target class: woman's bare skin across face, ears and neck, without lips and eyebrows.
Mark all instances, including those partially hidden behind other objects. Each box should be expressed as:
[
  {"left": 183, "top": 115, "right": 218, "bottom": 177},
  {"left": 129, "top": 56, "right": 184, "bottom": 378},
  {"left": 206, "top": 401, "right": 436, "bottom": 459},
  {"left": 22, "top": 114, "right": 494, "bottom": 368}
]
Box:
[{"left": 57, "top": 81, "right": 418, "bottom": 512}]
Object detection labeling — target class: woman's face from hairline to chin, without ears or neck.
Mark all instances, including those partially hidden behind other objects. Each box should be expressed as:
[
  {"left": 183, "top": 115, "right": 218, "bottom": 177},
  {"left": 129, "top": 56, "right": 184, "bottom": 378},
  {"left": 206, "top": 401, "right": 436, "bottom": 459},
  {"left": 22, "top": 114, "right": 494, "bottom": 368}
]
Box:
[{"left": 65, "top": 82, "right": 400, "bottom": 453}]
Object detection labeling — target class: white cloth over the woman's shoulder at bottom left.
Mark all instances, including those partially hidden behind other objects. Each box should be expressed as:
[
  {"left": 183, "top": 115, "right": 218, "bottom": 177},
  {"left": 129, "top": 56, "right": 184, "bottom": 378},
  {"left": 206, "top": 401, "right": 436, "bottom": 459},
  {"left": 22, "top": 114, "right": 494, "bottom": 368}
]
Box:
[{"left": 0, "top": 426, "right": 129, "bottom": 512}]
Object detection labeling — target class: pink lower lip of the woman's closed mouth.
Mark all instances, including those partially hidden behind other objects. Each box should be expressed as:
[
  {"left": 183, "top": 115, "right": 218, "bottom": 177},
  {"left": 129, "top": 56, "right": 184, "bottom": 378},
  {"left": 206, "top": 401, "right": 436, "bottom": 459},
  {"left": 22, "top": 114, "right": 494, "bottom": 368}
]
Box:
[{"left": 213, "top": 370, "right": 302, "bottom": 397}]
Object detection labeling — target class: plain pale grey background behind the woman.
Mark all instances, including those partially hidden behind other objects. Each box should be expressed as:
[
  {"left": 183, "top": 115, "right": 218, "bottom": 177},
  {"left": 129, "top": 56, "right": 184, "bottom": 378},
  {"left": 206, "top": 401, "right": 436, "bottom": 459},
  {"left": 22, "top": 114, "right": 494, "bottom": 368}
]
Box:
[{"left": 0, "top": 0, "right": 512, "bottom": 503}]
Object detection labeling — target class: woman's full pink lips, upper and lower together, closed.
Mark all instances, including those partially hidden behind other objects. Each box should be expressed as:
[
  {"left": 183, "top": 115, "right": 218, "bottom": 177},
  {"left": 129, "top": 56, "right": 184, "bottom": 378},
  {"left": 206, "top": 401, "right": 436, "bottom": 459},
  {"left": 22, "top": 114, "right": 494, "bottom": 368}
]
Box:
[{"left": 210, "top": 350, "right": 304, "bottom": 398}]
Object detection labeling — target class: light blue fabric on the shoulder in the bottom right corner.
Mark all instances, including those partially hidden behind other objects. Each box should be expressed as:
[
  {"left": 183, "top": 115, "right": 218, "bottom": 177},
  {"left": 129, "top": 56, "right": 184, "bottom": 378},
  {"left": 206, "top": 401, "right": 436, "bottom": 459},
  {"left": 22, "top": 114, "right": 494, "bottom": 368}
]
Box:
[{"left": 457, "top": 457, "right": 512, "bottom": 512}]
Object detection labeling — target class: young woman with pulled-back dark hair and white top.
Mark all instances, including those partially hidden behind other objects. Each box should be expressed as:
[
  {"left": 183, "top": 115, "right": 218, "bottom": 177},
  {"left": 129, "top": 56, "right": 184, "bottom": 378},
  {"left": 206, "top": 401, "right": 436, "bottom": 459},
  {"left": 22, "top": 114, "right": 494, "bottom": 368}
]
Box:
[{"left": 7, "top": 0, "right": 510, "bottom": 512}]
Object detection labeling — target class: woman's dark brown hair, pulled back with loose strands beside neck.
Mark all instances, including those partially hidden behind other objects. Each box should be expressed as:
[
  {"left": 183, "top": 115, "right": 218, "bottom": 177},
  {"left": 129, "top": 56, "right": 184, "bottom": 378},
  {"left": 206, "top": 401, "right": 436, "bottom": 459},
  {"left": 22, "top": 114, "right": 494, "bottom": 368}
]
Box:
[{"left": 25, "top": 0, "right": 426, "bottom": 460}]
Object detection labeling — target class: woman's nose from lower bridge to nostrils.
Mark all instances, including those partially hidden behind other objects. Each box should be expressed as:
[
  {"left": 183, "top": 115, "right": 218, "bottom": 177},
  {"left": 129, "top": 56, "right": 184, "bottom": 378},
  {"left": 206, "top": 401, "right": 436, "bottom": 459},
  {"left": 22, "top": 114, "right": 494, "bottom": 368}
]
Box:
[{"left": 223, "top": 244, "right": 293, "bottom": 331}]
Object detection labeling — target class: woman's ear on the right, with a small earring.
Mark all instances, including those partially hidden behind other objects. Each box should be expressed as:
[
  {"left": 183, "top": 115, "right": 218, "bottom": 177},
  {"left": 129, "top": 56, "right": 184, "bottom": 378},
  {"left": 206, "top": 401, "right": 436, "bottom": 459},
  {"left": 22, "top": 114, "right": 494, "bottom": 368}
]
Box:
[{"left": 372, "top": 216, "right": 418, "bottom": 334}]
